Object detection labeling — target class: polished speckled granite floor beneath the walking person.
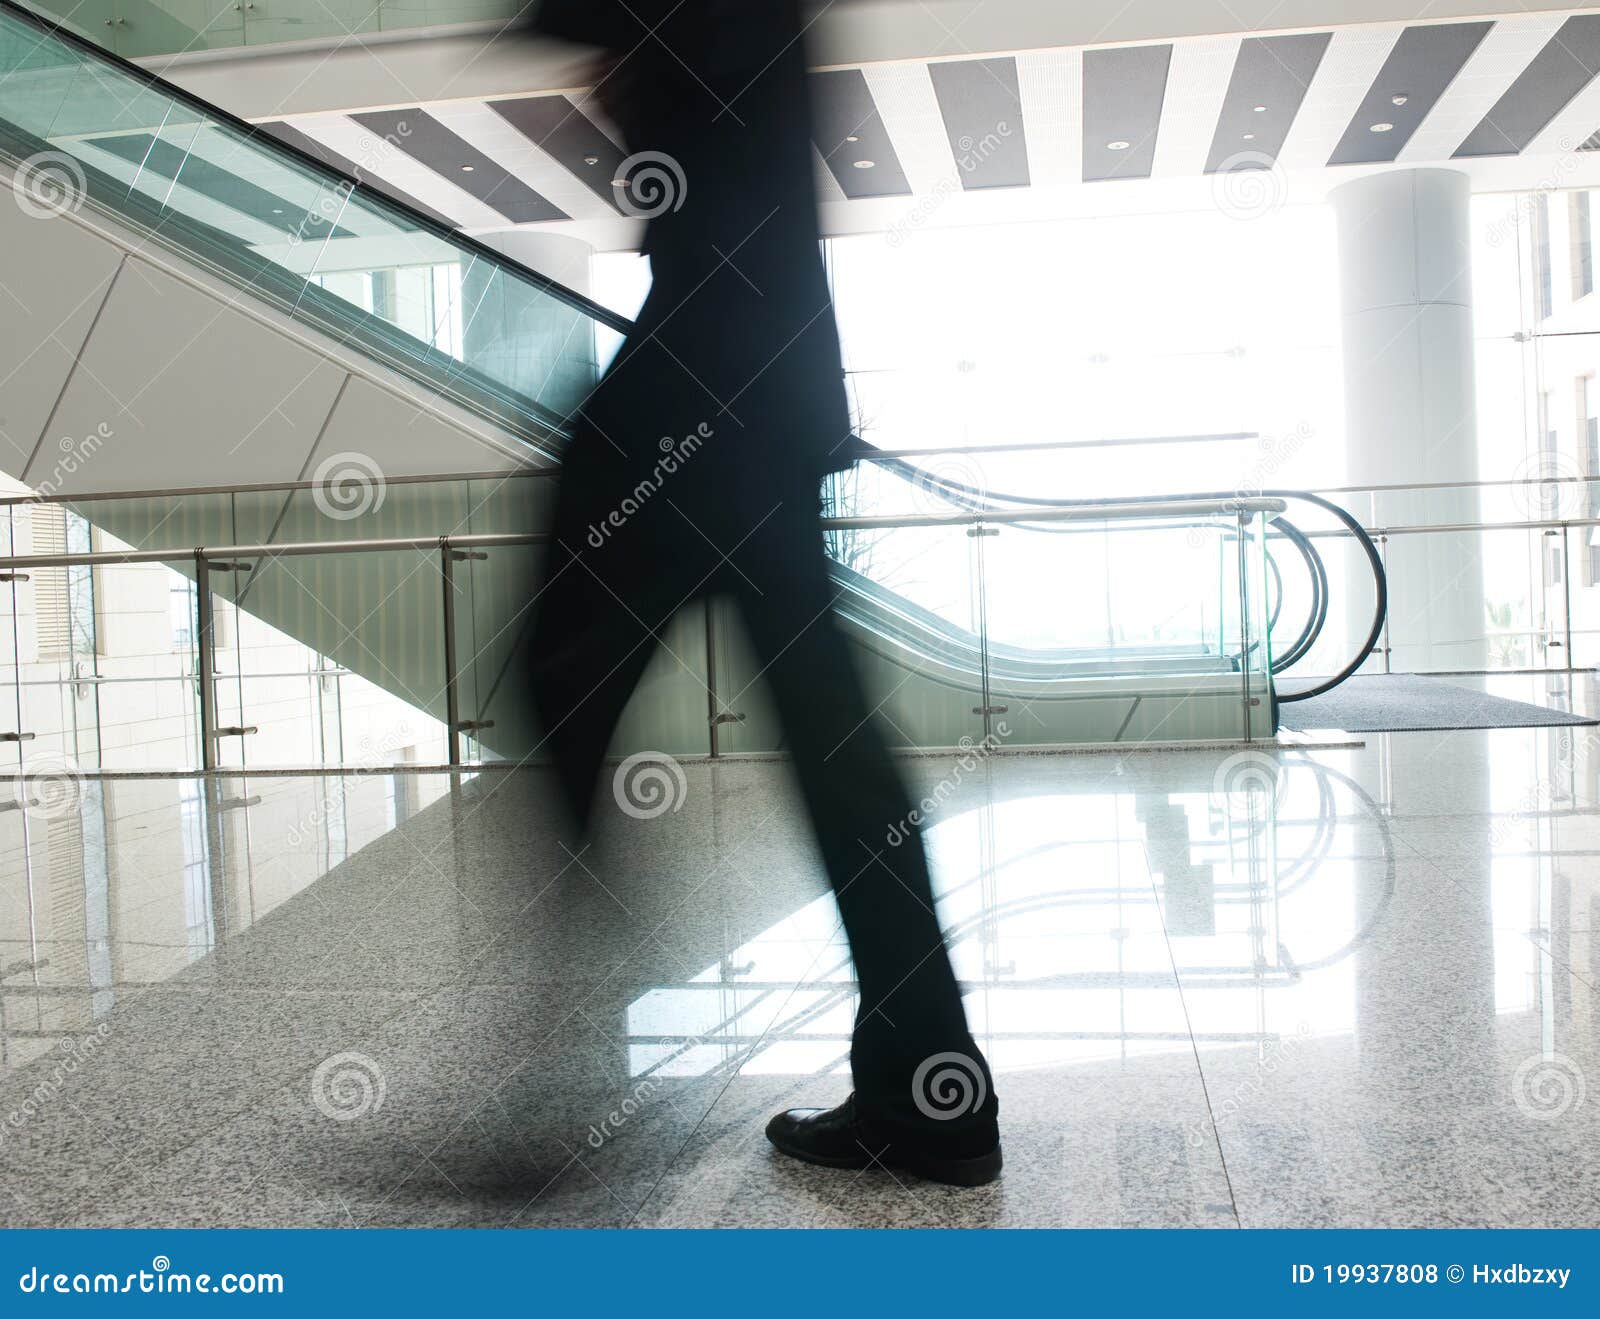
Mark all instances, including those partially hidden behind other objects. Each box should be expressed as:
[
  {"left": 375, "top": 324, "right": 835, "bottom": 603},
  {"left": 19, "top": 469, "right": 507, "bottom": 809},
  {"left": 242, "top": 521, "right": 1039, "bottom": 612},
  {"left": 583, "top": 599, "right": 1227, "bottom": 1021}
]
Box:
[{"left": 0, "top": 680, "right": 1600, "bottom": 1228}]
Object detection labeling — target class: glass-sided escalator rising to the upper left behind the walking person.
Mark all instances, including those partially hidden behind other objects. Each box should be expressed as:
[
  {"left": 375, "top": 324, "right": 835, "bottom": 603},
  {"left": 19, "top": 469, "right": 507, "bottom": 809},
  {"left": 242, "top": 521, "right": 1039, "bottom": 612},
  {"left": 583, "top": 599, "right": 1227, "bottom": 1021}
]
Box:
[{"left": 0, "top": 0, "right": 1384, "bottom": 757}]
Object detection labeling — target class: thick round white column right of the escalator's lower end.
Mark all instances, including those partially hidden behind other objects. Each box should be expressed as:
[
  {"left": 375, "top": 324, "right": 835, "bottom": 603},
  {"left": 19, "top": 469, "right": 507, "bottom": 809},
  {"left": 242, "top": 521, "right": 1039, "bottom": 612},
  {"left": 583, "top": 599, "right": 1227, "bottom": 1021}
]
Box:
[{"left": 1330, "top": 170, "right": 1486, "bottom": 672}]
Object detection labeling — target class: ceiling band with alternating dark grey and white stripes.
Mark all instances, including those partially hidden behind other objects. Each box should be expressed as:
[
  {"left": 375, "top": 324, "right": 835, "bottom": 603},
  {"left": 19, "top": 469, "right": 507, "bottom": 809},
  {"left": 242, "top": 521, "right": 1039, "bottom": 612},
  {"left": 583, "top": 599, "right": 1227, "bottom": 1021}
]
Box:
[{"left": 249, "top": 11, "right": 1600, "bottom": 229}]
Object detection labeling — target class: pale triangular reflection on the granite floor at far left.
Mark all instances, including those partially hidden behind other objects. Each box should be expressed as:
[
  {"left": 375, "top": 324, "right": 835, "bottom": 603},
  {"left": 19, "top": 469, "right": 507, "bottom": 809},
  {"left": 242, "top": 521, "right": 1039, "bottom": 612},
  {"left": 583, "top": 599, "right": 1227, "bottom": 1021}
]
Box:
[{"left": 0, "top": 775, "right": 448, "bottom": 1071}]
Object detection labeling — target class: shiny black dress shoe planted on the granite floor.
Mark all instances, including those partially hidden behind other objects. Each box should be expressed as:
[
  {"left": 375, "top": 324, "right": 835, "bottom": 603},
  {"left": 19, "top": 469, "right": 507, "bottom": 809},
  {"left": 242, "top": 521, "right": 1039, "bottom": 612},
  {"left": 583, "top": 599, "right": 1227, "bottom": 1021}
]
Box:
[{"left": 766, "top": 1095, "right": 1000, "bottom": 1186}]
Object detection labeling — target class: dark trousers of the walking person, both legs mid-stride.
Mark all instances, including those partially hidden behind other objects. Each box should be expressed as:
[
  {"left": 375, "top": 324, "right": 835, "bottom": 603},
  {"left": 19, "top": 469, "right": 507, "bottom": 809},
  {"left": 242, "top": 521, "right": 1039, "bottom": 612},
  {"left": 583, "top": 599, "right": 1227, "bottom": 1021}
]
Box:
[{"left": 534, "top": 451, "right": 997, "bottom": 1137}]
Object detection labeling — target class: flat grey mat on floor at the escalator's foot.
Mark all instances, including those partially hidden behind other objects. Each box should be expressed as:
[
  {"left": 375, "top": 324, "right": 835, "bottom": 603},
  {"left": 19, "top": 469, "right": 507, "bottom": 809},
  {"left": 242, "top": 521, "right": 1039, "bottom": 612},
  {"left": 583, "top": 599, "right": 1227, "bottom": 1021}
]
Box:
[{"left": 1278, "top": 674, "right": 1600, "bottom": 733}]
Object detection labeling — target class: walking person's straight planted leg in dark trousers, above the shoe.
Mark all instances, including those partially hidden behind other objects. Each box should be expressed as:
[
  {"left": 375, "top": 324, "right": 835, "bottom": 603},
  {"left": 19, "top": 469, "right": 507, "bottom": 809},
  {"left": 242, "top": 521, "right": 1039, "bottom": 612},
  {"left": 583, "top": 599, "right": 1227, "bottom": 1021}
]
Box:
[{"left": 730, "top": 493, "right": 998, "bottom": 1167}]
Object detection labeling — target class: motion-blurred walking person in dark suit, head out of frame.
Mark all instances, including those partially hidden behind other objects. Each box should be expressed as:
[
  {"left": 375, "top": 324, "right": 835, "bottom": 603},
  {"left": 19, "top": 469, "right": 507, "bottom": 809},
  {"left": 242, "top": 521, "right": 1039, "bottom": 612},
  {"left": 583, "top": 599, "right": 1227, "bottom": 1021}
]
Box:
[{"left": 533, "top": 0, "right": 1002, "bottom": 1186}]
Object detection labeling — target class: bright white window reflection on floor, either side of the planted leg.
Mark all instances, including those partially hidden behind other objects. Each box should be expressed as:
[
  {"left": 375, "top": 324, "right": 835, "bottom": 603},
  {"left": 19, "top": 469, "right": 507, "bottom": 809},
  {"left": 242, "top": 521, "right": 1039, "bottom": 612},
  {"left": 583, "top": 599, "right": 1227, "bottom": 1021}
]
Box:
[{"left": 627, "top": 752, "right": 1414, "bottom": 1076}]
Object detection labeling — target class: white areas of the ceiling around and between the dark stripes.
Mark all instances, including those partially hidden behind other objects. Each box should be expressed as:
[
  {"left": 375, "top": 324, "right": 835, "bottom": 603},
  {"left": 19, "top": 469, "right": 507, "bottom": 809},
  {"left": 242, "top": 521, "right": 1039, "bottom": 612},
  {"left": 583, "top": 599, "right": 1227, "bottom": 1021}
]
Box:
[{"left": 147, "top": 0, "right": 1600, "bottom": 250}]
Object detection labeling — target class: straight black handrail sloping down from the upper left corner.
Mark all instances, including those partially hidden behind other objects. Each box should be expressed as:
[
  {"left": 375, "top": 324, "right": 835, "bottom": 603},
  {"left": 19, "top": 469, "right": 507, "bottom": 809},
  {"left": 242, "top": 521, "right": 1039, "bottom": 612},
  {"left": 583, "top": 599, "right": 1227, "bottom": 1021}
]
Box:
[{"left": 0, "top": 0, "right": 634, "bottom": 335}]
